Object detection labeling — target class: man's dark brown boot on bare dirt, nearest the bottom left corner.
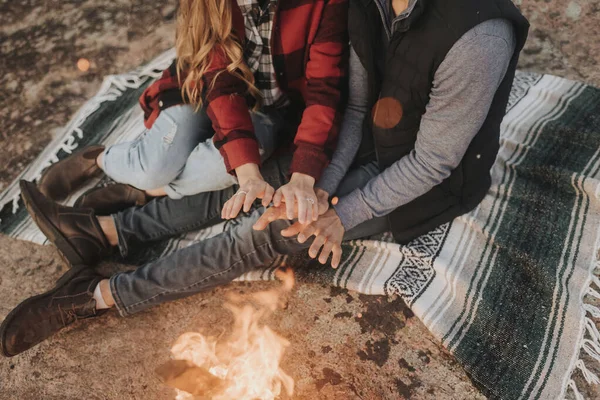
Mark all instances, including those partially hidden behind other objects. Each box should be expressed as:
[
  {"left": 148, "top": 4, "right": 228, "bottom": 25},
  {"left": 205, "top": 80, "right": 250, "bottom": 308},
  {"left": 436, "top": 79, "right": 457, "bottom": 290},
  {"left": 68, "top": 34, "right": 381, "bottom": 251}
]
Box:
[{"left": 0, "top": 266, "right": 107, "bottom": 357}]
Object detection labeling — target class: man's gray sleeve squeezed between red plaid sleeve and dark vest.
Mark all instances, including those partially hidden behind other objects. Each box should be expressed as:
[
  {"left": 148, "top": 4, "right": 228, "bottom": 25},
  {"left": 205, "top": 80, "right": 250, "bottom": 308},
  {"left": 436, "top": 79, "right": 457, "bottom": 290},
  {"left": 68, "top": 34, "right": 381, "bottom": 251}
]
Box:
[{"left": 316, "top": 46, "right": 368, "bottom": 195}]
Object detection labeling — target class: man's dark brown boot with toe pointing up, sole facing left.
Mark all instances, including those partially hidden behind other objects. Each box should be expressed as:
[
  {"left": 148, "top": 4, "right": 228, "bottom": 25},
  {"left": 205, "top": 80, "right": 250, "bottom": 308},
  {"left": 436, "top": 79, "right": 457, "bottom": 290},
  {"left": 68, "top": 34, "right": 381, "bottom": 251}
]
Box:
[{"left": 20, "top": 181, "right": 111, "bottom": 265}]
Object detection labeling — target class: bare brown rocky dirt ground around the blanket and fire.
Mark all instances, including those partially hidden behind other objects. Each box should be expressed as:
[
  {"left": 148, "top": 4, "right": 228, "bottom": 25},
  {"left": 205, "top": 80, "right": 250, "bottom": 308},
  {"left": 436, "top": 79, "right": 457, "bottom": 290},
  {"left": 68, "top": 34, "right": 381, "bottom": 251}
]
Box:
[{"left": 0, "top": 0, "right": 600, "bottom": 400}]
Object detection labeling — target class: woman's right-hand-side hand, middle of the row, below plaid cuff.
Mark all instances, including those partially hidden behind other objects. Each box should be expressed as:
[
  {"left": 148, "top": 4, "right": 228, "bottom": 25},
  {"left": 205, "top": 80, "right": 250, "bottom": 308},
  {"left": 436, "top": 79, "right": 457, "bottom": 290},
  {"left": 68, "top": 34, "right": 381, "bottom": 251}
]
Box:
[{"left": 273, "top": 172, "right": 319, "bottom": 225}]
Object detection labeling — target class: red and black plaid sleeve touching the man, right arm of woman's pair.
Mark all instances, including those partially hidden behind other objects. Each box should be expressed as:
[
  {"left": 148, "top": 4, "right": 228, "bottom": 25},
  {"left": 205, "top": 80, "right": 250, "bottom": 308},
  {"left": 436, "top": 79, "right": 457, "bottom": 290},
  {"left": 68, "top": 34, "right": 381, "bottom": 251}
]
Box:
[{"left": 290, "top": 0, "right": 349, "bottom": 180}]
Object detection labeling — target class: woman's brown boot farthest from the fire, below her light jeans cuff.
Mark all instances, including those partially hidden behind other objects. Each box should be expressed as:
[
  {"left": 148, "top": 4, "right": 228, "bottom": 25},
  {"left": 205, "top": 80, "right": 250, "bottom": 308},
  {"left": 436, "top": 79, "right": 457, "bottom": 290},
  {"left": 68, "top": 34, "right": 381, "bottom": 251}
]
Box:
[{"left": 39, "top": 146, "right": 104, "bottom": 201}]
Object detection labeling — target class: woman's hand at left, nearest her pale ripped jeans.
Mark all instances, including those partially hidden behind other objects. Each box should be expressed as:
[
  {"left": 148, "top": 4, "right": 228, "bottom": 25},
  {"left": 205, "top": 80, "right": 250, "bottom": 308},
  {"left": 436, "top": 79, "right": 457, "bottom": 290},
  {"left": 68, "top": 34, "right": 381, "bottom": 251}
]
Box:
[{"left": 221, "top": 164, "right": 275, "bottom": 219}]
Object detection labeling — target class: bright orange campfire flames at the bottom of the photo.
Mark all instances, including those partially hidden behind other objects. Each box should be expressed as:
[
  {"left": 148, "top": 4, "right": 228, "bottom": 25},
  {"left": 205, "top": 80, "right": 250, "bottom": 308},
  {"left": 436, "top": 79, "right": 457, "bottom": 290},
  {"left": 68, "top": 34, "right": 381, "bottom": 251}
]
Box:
[{"left": 157, "top": 269, "right": 294, "bottom": 400}]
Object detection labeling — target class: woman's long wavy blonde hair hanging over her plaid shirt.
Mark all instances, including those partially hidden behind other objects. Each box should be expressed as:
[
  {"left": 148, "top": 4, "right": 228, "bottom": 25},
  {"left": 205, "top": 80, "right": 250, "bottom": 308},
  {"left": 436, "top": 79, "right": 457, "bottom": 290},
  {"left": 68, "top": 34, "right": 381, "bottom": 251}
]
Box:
[{"left": 175, "top": 0, "right": 260, "bottom": 109}]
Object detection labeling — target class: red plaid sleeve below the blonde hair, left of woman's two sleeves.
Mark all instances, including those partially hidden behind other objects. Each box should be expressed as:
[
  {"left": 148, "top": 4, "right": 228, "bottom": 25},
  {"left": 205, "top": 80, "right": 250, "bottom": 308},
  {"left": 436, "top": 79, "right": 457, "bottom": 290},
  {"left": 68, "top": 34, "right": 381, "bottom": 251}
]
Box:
[{"left": 203, "top": 47, "right": 260, "bottom": 173}]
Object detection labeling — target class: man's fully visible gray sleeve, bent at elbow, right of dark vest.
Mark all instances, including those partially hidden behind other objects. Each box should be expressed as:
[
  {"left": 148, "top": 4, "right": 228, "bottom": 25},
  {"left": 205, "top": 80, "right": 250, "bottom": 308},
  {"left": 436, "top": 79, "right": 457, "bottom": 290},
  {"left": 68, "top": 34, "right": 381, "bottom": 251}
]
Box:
[{"left": 335, "top": 19, "right": 515, "bottom": 230}]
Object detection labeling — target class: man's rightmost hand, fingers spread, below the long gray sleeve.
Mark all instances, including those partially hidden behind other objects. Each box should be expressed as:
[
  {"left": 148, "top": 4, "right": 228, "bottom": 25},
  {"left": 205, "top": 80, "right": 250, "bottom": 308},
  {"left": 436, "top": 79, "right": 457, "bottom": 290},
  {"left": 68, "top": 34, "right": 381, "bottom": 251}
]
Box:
[{"left": 281, "top": 208, "right": 345, "bottom": 268}]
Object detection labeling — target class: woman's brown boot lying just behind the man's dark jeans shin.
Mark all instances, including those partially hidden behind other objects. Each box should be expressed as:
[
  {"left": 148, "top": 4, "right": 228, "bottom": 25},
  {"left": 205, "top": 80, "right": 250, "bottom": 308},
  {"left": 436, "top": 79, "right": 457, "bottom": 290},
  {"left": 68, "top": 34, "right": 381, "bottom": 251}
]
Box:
[{"left": 73, "top": 183, "right": 148, "bottom": 215}]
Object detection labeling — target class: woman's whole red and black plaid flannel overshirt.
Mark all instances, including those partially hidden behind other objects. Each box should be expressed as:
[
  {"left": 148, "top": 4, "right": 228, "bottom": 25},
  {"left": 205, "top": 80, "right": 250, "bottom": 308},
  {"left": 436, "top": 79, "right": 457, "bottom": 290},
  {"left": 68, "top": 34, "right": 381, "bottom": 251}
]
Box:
[{"left": 140, "top": 0, "right": 349, "bottom": 179}]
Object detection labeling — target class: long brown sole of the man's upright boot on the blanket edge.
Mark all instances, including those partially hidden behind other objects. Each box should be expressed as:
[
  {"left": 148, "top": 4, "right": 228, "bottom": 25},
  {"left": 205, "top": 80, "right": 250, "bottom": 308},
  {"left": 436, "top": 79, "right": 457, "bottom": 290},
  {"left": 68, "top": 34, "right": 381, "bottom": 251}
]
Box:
[{"left": 19, "top": 181, "right": 87, "bottom": 265}]
